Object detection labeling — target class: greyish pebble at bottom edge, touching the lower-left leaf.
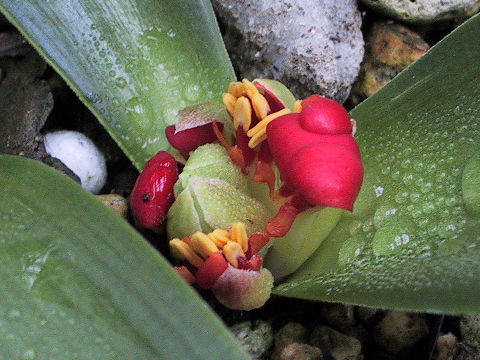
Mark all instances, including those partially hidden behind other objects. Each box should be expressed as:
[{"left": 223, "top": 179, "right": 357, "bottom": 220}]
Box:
[{"left": 230, "top": 320, "right": 273, "bottom": 359}]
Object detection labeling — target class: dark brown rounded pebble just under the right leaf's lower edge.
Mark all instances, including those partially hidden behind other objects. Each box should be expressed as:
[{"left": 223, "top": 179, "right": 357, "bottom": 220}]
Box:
[{"left": 373, "top": 311, "right": 429, "bottom": 354}]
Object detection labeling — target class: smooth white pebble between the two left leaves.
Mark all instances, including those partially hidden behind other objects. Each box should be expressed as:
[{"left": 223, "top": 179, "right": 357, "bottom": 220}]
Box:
[{"left": 44, "top": 130, "right": 107, "bottom": 194}]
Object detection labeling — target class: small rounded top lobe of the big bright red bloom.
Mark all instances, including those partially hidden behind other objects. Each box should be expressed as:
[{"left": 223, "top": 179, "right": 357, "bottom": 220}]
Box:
[{"left": 300, "top": 95, "right": 352, "bottom": 134}]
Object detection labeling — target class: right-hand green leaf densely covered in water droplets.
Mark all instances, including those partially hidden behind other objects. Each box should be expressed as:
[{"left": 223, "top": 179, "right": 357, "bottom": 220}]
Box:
[{"left": 275, "top": 16, "right": 480, "bottom": 313}]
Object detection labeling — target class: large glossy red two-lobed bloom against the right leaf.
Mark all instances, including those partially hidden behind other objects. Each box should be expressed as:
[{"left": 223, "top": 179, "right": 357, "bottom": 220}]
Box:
[{"left": 267, "top": 95, "right": 363, "bottom": 211}]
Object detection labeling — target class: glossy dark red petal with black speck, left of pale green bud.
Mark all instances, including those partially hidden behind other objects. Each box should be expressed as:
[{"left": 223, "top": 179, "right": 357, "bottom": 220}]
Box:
[{"left": 130, "top": 151, "right": 178, "bottom": 232}]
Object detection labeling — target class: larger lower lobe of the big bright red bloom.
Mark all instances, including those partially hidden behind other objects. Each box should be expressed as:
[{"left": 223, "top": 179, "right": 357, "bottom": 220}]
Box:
[{"left": 289, "top": 143, "right": 363, "bottom": 211}]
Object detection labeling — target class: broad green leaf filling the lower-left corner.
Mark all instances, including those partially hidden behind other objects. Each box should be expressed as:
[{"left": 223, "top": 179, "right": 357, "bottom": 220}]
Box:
[{"left": 0, "top": 156, "right": 249, "bottom": 360}]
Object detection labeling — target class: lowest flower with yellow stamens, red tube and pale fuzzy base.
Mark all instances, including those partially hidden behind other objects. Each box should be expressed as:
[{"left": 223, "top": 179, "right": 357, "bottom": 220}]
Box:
[{"left": 170, "top": 222, "right": 273, "bottom": 310}]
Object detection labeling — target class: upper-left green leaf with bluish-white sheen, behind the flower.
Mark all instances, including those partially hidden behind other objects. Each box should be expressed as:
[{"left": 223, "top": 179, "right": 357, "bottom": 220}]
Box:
[{"left": 0, "top": 0, "right": 234, "bottom": 168}]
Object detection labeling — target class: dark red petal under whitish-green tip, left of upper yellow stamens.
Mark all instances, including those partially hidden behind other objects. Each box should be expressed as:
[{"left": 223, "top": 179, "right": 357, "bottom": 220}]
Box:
[{"left": 165, "top": 123, "right": 223, "bottom": 152}]
